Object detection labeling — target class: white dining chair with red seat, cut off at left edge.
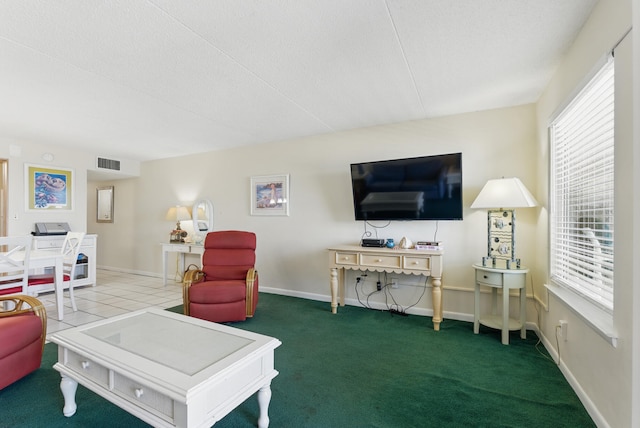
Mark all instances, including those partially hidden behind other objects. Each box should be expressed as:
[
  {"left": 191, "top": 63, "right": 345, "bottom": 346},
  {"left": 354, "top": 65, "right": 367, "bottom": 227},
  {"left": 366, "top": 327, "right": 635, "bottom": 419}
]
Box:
[{"left": 0, "top": 236, "right": 32, "bottom": 295}]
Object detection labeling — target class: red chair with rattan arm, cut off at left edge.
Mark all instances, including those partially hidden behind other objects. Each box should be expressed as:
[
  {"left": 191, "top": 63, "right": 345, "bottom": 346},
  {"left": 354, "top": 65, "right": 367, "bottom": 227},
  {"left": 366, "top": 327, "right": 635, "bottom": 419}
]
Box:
[{"left": 0, "top": 294, "right": 47, "bottom": 389}]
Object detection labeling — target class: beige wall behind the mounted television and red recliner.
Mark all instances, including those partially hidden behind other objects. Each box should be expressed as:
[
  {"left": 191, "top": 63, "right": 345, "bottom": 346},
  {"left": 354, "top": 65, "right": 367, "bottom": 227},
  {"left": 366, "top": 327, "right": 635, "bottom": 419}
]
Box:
[{"left": 89, "top": 105, "right": 536, "bottom": 319}]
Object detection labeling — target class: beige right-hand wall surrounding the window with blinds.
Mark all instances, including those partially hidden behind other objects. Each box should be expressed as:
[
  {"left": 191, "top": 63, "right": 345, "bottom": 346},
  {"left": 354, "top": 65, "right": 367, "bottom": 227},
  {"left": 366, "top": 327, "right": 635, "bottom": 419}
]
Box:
[{"left": 535, "top": 0, "right": 640, "bottom": 427}]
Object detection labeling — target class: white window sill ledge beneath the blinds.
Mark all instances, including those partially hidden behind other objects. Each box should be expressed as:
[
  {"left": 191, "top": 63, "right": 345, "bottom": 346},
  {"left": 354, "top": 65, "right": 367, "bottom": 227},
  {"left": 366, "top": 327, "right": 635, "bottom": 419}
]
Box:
[{"left": 544, "top": 284, "right": 618, "bottom": 348}]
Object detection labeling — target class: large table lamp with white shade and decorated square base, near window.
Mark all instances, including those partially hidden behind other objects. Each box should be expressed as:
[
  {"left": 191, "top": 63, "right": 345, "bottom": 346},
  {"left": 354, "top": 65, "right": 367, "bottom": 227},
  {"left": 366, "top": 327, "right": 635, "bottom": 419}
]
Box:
[{"left": 471, "top": 177, "right": 538, "bottom": 269}]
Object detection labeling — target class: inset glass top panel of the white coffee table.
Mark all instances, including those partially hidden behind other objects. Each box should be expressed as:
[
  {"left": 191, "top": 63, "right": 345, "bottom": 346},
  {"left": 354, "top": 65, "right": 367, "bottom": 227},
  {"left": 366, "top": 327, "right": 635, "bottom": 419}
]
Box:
[{"left": 83, "top": 312, "right": 254, "bottom": 375}]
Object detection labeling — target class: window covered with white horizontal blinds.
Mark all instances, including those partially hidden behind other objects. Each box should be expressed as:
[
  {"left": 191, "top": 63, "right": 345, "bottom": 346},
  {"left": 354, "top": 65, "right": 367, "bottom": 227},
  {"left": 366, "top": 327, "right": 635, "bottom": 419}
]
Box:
[{"left": 549, "top": 57, "right": 614, "bottom": 313}]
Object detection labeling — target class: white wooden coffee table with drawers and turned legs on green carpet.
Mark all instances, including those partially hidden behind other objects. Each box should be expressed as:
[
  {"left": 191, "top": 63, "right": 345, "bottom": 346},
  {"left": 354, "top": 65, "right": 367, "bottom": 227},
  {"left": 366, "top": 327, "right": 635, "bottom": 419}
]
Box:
[{"left": 51, "top": 308, "right": 281, "bottom": 428}]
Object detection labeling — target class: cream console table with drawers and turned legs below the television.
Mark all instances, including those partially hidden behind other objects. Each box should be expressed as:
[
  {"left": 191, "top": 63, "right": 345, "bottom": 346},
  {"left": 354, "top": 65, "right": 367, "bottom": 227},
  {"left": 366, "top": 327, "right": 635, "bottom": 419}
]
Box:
[{"left": 329, "top": 245, "right": 444, "bottom": 331}]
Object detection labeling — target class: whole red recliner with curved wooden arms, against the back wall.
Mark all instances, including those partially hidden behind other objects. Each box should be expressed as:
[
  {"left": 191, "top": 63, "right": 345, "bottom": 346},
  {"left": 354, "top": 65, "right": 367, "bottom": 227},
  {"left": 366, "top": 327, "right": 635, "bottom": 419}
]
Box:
[{"left": 183, "top": 230, "right": 258, "bottom": 322}]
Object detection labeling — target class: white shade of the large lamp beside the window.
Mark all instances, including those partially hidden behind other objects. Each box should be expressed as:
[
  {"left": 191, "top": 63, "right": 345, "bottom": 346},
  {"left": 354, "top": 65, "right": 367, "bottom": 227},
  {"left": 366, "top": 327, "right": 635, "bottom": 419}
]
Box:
[{"left": 471, "top": 177, "right": 538, "bottom": 208}]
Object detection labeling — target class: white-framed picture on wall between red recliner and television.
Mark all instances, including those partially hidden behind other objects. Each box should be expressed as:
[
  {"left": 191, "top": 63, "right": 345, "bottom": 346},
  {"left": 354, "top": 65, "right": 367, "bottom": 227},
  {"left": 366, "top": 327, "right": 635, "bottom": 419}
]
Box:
[{"left": 251, "top": 174, "right": 289, "bottom": 216}]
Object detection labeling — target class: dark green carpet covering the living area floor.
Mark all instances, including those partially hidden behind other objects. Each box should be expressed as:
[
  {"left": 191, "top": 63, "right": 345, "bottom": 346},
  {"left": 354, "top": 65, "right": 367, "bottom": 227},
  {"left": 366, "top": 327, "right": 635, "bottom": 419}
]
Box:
[{"left": 0, "top": 293, "right": 595, "bottom": 428}]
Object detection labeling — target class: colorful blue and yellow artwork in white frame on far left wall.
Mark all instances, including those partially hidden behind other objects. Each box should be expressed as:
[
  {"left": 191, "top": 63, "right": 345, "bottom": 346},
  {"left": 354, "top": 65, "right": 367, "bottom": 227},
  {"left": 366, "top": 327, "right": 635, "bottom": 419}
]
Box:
[{"left": 24, "top": 164, "right": 74, "bottom": 211}]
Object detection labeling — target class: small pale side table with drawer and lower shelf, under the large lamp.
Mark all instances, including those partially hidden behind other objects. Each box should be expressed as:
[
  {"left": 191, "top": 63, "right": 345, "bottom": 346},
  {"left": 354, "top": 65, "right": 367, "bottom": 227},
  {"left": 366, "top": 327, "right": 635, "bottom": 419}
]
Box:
[{"left": 473, "top": 264, "right": 529, "bottom": 345}]
